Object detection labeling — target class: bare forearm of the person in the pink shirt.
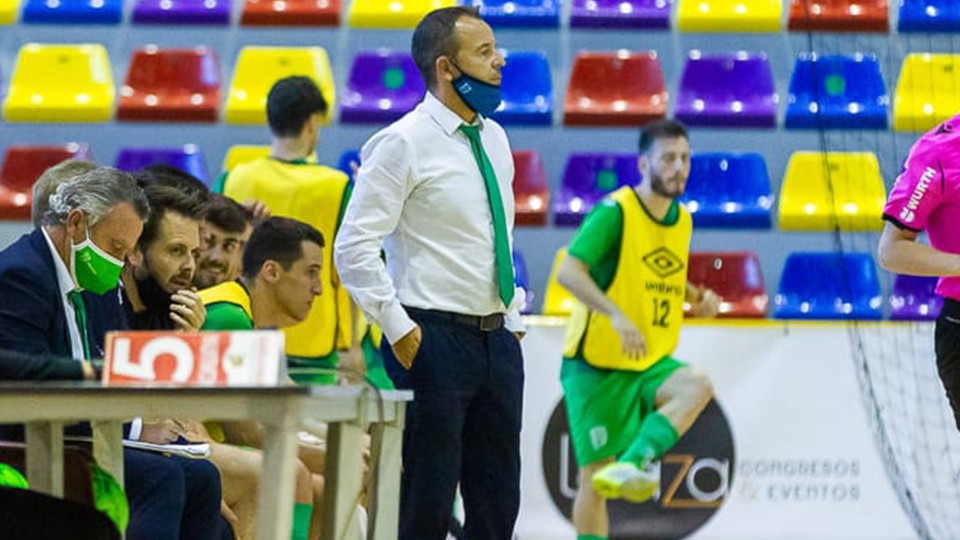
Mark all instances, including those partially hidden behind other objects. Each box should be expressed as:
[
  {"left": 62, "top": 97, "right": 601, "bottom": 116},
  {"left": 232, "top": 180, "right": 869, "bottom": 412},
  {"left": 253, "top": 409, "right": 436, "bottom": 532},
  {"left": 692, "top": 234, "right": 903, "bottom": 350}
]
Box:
[{"left": 877, "top": 221, "right": 960, "bottom": 276}]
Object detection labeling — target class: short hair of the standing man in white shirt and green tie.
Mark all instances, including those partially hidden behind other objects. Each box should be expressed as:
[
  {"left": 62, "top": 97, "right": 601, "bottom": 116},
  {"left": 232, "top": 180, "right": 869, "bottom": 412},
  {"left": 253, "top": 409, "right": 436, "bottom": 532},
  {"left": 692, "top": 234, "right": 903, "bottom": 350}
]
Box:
[{"left": 410, "top": 6, "right": 482, "bottom": 88}]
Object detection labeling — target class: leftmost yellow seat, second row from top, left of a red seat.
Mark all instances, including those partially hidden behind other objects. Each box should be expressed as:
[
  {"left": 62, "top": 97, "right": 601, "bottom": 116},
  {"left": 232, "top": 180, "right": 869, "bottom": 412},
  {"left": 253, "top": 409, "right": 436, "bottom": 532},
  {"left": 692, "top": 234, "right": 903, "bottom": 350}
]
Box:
[{"left": 3, "top": 43, "right": 115, "bottom": 122}]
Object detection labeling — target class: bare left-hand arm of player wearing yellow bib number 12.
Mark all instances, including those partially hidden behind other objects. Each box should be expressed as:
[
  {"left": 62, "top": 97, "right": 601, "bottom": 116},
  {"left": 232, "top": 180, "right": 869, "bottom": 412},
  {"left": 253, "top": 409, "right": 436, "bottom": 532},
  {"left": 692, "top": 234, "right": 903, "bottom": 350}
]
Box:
[{"left": 557, "top": 255, "right": 647, "bottom": 359}]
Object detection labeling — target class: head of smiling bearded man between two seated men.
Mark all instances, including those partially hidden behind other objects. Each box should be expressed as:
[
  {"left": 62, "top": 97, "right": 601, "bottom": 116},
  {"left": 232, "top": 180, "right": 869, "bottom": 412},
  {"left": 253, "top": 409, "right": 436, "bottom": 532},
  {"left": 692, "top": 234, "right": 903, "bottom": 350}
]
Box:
[{"left": 193, "top": 194, "right": 253, "bottom": 289}]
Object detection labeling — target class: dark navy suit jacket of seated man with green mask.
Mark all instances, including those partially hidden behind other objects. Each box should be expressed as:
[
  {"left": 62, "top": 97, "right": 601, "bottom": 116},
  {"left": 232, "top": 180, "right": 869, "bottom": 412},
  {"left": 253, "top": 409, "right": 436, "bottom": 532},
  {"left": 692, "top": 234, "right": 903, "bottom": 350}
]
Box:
[{"left": 0, "top": 230, "right": 126, "bottom": 370}]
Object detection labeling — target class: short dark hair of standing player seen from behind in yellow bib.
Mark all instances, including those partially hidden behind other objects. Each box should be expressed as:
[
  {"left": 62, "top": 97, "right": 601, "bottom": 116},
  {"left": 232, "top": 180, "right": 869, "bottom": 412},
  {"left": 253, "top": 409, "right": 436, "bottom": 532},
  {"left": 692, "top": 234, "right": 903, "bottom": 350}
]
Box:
[{"left": 267, "top": 75, "right": 329, "bottom": 137}]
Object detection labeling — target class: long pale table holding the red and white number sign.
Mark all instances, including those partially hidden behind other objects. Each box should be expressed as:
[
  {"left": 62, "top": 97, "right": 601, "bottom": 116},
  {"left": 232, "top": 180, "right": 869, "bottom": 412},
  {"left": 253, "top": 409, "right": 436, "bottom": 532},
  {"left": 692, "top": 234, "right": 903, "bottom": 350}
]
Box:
[{"left": 0, "top": 382, "right": 413, "bottom": 540}]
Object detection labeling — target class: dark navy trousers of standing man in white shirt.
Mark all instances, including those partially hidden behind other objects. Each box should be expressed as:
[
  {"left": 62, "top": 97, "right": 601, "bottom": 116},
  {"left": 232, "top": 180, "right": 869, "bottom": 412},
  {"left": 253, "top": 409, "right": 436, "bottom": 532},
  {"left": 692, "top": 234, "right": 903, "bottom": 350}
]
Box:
[{"left": 382, "top": 310, "right": 523, "bottom": 540}]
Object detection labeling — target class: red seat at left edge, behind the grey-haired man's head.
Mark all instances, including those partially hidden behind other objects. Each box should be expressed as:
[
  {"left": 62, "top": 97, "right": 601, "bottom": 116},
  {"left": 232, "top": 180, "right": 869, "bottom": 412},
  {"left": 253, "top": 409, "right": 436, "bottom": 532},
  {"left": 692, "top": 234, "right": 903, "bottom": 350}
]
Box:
[{"left": 0, "top": 143, "right": 93, "bottom": 220}]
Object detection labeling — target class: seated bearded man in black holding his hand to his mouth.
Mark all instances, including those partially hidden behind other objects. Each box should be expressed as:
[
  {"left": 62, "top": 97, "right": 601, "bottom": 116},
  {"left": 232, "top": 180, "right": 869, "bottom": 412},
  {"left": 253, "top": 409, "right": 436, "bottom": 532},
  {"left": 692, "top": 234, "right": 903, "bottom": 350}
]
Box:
[{"left": 122, "top": 184, "right": 206, "bottom": 331}]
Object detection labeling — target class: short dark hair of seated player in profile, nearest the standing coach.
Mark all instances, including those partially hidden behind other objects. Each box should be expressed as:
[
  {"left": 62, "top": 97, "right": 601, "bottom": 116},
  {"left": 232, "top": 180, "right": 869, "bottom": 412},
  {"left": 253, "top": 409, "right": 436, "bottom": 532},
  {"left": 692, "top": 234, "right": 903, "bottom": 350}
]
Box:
[{"left": 243, "top": 217, "right": 324, "bottom": 279}]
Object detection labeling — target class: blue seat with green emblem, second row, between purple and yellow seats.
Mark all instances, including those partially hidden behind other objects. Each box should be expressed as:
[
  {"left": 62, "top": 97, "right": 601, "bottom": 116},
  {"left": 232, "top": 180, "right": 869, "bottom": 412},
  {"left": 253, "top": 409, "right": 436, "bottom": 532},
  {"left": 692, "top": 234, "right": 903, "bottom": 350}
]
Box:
[{"left": 785, "top": 53, "right": 890, "bottom": 129}]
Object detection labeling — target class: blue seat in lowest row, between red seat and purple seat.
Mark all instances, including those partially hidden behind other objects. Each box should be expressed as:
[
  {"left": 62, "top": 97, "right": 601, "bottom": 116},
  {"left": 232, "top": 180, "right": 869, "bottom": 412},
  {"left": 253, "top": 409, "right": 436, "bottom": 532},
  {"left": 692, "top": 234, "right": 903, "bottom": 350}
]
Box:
[{"left": 773, "top": 252, "right": 883, "bottom": 320}]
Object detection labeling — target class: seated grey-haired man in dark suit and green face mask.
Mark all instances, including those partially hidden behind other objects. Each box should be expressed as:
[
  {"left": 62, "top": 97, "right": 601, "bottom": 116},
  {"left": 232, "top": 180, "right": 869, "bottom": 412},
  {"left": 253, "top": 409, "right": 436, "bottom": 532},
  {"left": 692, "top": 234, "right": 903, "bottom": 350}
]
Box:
[{"left": 0, "top": 167, "right": 222, "bottom": 540}]
